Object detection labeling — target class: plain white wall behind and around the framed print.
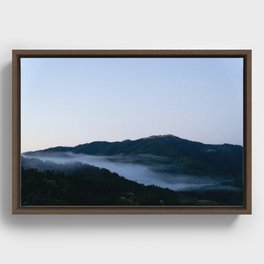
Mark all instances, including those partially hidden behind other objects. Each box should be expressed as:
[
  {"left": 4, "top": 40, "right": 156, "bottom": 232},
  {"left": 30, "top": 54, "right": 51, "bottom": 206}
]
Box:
[{"left": 0, "top": 0, "right": 264, "bottom": 264}]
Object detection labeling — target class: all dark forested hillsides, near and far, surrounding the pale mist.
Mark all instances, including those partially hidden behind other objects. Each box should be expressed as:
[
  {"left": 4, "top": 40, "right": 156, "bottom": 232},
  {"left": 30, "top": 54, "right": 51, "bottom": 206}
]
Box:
[{"left": 22, "top": 135, "right": 243, "bottom": 206}]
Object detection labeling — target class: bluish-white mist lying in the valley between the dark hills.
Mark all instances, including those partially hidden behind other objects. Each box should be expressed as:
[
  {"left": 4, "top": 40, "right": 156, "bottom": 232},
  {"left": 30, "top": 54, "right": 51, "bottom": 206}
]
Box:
[{"left": 22, "top": 152, "right": 239, "bottom": 191}]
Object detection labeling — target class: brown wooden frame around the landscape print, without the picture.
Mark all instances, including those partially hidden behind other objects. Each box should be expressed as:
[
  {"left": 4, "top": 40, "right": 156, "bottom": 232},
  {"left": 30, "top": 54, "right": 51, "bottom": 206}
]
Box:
[{"left": 12, "top": 50, "right": 252, "bottom": 214}]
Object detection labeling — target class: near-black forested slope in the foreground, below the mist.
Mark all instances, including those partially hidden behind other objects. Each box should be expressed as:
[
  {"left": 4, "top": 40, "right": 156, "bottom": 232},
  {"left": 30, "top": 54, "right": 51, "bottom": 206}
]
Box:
[{"left": 21, "top": 164, "right": 243, "bottom": 206}]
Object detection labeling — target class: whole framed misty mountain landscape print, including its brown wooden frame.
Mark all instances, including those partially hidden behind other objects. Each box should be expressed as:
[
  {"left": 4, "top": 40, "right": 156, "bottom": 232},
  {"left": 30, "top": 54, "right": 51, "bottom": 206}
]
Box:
[{"left": 13, "top": 50, "right": 251, "bottom": 214}]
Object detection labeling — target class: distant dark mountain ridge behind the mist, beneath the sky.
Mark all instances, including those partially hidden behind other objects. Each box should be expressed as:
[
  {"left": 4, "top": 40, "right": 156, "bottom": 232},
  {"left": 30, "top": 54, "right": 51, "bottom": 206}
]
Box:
[{"left": 25, "top": 135, "right": 243, "bottom": 180}]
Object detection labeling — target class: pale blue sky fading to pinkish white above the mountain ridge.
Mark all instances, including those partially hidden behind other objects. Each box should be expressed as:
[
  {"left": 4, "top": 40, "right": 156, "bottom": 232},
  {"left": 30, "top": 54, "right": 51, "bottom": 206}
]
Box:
[{"left": 21, "top": 58, "right": 243, "bottom": 152}]
